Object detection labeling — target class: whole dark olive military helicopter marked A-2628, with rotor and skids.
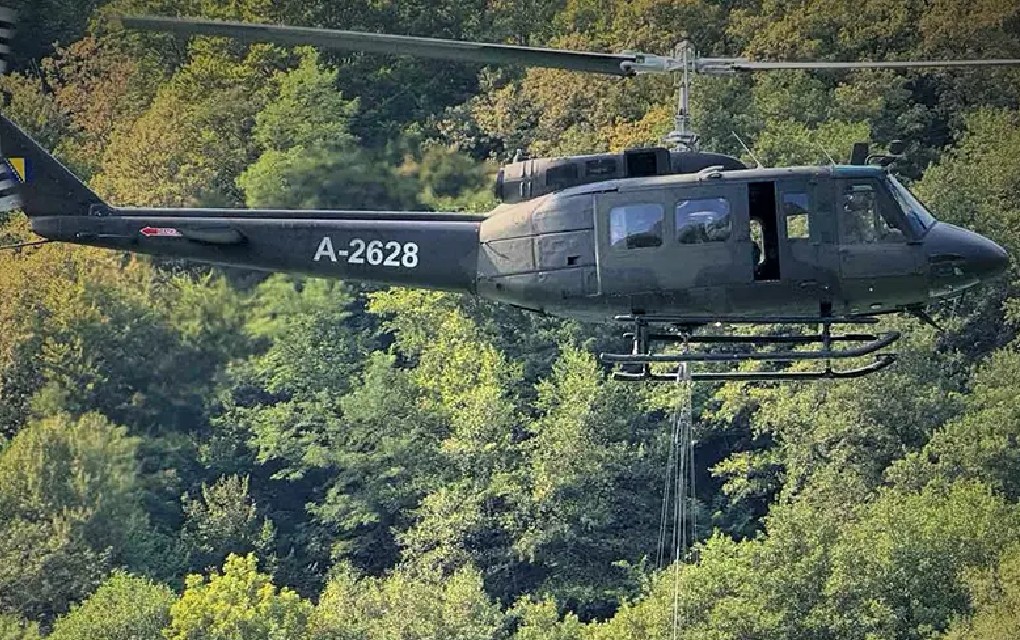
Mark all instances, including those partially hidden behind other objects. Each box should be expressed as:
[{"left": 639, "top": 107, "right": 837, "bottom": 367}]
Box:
[{"left": 0, "top": 12, "right": 1020, "bottom": 381}]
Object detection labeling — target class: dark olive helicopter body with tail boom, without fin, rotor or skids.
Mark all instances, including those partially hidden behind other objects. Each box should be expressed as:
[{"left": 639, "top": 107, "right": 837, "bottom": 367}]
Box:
[{"left": 32, "top": 166, "right": 1006, "bottom": 321}]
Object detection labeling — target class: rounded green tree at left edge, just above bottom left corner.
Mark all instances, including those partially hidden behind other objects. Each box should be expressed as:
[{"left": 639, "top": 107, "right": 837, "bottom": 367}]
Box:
[{"left": 0, "top": 413, "right": 152, "bottom": 620}]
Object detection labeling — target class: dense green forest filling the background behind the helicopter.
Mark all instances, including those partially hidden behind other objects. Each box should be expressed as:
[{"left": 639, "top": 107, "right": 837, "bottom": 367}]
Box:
[{"left": 0, "top": 0, "right": 1020, "bottom": 640}]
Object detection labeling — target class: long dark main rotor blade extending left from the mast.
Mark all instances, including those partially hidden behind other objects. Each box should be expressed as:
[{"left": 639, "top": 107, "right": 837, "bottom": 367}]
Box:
[{"left": 120, "top": 15, "right": 643, "bottom": 76}]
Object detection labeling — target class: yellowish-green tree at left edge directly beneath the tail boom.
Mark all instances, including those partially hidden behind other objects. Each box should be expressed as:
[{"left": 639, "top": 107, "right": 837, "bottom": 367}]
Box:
[{"left": 0, "top": 232, "right": 247, "bottom": 438}]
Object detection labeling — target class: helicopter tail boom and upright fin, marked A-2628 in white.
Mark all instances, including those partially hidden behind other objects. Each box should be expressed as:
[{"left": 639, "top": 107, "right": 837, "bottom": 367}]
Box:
[{"left": 0, "top": 115, "right": 485, "bottom": 293}]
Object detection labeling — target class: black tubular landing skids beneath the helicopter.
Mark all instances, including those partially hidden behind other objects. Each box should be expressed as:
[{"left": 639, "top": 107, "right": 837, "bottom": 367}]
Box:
[{"left": 600, "top": 309, "right": 900, "bottom": 382}]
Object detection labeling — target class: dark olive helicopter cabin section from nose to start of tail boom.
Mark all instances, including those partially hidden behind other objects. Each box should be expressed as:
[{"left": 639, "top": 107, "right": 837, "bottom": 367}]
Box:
[{"left": 476, "top": 166, "right": 1005, "bottom": 319}]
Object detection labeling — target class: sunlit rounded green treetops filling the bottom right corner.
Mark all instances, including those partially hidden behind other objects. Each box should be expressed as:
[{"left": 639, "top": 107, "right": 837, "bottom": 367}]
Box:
[{"left": 590, "top": 483, "right": 1018, "bottom": 640}]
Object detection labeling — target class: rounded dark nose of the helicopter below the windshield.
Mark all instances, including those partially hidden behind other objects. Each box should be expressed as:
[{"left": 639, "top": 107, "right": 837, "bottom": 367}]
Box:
[{"left": 924, "top": 223, "right": 1010, "bottom": 295}]
